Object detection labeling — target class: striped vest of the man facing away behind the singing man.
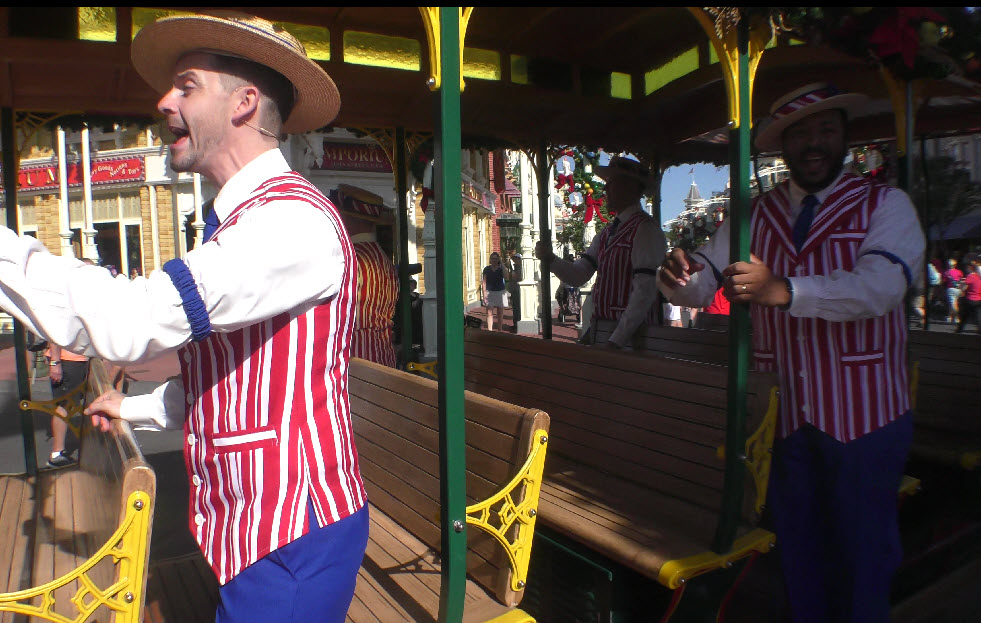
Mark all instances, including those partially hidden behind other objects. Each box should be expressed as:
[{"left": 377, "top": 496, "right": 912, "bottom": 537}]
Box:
[{"left": 351, "top": 242, "right": 399, "bottom": 368}]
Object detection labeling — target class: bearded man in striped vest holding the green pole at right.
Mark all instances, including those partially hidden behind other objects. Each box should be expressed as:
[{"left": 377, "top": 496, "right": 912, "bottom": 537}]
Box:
[{"left": 659, "top": 84, "right": 925, "bottom": 622}]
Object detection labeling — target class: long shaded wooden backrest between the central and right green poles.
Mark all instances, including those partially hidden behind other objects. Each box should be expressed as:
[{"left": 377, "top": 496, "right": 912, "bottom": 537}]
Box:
[{"left": 465, "top": 329, "right": 776, "bottom": 523}]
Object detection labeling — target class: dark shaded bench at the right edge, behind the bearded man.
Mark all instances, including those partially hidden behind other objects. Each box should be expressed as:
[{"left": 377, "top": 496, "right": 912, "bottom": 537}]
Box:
[{"left": 909, "top": 330, "right": 981, "bottom": 470}]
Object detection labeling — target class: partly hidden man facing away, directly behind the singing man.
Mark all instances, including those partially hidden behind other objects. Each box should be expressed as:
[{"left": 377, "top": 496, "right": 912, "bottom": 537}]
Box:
[{"left": 332, "top": 184, "right": 399, "bottom": 368}]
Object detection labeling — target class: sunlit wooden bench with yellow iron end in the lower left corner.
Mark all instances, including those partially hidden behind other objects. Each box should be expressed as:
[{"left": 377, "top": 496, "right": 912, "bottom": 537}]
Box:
[{"left": 0, "top": 360, "right": 156, "bottom": 623}]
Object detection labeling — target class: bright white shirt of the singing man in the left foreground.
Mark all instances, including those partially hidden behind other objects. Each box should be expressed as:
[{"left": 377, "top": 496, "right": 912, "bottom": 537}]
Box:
[{"left": 0, "top": 149, "right": 344, "bottom": 427}]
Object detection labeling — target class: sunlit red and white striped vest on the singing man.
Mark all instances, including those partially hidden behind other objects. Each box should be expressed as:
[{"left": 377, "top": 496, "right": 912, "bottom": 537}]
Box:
[{"left": 179, "top": 173, "right": 367, "bottom": 584}]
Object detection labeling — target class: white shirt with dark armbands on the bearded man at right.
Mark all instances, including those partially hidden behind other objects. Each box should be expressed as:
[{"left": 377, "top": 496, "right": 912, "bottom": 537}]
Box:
[{"left": 658, "top": 175, "right": 926, "bottom": 321}]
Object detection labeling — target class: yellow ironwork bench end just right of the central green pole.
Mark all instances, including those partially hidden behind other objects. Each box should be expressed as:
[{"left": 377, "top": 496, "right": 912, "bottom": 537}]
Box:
[{"left": 467, "top": 429, "right": 548, "bottom": 591}]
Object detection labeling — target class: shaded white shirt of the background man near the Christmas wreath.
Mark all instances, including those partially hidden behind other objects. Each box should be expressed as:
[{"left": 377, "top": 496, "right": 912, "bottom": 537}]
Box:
[{"left": 550, "top": 203, "right": 667, "bottom": 346}]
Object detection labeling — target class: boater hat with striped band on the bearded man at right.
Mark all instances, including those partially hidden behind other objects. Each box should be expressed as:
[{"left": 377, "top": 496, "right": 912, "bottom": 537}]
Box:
[{"left": 756, "top": 82, "right": 868, "bottom": 151}]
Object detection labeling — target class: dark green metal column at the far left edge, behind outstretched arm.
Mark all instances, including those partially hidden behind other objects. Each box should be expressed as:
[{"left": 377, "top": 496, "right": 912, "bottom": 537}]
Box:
[{"left": 0, "top": 108, "right": 37, "bottom": 476}]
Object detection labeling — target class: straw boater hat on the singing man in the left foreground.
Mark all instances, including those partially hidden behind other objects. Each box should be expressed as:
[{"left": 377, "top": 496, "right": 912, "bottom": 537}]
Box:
[{"left": 131, "top": 11, "right": 341, "bottom": 134}]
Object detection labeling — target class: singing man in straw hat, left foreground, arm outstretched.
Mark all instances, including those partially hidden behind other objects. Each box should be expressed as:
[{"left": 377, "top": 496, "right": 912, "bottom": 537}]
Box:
[{"left": 0, "top": 12, "right": 368, "bottom": 623}]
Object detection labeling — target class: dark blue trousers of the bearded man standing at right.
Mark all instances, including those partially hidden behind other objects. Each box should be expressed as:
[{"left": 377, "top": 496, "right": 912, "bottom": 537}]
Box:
[{"left": 767, "top": 412, "right": 913, "bottom": 623}]
